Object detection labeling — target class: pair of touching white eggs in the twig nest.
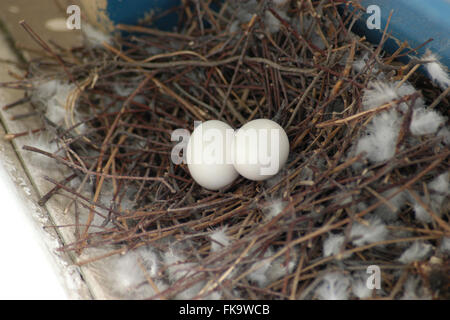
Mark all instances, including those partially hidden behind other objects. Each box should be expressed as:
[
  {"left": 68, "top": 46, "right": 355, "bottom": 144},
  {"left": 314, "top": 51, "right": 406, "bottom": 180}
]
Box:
[{"left": 186, "top": 119, "right": 289, "bottom": 190}]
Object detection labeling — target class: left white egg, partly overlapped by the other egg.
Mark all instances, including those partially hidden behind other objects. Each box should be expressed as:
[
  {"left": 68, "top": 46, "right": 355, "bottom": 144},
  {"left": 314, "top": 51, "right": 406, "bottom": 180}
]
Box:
[{"left": 186, "top": 120, "right": 239, "bottom": 190}]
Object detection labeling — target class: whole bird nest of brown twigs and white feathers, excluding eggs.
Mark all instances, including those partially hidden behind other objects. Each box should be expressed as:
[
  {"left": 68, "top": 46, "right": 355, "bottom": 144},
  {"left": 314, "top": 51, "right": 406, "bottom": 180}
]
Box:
[{"left": 4, "top": 0, "right": 450, "bottom": 299}]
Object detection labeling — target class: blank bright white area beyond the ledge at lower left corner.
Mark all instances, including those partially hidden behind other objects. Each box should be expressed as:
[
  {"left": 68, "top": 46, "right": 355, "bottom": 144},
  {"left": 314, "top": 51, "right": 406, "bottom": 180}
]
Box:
[{"left": 0, "top": 162, "right": 67, "bottom": 299}]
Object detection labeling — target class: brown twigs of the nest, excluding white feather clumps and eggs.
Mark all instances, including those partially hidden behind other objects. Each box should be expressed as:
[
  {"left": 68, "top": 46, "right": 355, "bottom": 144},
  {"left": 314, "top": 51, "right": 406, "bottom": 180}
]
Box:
[{"left": 1, "top": 1, "right": 449, "bottom": 299}]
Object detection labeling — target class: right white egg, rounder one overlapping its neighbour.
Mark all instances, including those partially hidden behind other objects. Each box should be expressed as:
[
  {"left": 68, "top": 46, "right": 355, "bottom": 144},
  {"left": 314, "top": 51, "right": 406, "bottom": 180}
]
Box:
[{"left": 233, "top": 119, "right": 289, "bottom": 181}]
